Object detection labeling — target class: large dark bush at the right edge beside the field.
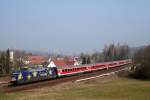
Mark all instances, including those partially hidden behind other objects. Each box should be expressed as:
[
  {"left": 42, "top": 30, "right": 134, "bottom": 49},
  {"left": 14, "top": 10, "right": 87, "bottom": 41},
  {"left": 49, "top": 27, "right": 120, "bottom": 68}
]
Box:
[{"left": 131, "top": 45, "right": 150, "bottom": 79}]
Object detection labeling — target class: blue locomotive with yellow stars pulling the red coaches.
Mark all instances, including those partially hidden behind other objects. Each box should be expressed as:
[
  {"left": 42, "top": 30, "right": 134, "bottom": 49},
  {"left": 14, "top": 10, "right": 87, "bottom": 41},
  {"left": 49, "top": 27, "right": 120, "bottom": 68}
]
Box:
[{"left": 11, "top": 66, "right": 57, "bottom": 85}]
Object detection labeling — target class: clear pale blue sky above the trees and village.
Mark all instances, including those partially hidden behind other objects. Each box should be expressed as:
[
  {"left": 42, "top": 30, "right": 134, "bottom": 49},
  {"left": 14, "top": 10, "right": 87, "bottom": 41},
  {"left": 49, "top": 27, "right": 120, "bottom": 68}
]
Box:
[{"left": 0, "top": 0, "right": 150, "bottom": 53}]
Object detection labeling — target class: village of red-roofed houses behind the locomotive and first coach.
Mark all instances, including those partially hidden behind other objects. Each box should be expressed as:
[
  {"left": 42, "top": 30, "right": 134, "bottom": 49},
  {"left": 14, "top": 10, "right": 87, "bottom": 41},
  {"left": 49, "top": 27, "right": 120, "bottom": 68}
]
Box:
[{"left": 10, "top": 50, "right": 82, "bottom": 67}]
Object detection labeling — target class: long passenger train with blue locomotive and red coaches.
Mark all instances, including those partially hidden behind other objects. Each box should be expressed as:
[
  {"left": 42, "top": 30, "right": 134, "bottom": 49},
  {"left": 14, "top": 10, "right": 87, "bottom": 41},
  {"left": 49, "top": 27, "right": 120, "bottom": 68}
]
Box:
[{"left": 10, "top": 59, "right": 132, "bottom": 85}]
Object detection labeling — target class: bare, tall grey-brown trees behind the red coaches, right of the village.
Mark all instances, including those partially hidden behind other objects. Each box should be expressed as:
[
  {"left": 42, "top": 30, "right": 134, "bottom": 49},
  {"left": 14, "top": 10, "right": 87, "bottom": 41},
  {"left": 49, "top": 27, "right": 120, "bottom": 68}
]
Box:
[{"left": 80, "top": 43, "right": 130, "bottom": 64}]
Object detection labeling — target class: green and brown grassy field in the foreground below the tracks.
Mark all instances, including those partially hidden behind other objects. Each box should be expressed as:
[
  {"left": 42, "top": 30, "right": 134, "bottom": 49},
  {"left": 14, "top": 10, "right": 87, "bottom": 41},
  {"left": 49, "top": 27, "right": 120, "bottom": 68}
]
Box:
[{"left": 0, "top": 75, "right": 150, "bottom": 100}]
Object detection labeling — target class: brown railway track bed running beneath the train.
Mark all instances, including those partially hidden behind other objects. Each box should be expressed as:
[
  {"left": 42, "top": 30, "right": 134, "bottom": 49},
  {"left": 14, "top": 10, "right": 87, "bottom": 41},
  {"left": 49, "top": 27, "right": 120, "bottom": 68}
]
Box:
[{"left": 0, "top": 65, "right": 129, "bottom": 93}]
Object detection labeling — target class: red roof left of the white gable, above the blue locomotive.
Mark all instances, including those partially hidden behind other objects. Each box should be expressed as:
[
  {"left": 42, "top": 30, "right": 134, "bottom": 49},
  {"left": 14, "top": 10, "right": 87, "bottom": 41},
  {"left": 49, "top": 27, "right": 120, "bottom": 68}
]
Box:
[{"left": 27, "top": 56, "right": 46, "bottom": 65}]
